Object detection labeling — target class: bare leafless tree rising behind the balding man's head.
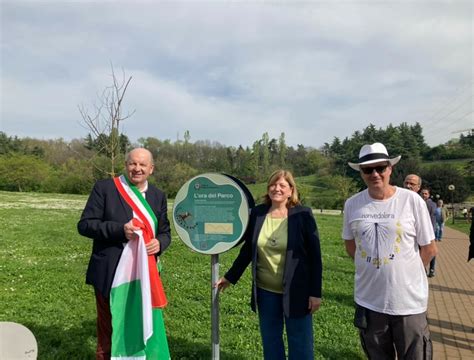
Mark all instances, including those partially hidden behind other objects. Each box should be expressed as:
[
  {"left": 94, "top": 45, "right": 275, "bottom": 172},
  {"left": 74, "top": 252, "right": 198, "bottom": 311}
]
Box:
[{"left": 78, "top": 65, "right": 135, "bottom": 177}]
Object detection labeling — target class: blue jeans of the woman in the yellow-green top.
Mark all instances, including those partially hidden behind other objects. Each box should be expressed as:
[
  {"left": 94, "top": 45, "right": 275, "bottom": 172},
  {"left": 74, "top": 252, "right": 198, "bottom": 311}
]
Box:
[{"left": 257, "top": 288, "right": 314, "bottom": 360}]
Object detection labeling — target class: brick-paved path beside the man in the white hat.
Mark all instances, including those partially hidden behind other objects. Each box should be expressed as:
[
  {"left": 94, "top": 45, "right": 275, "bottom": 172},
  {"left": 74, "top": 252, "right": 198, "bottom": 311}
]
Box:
[{"left": 428, "top": 228, "right": 474, "bottom": 360}]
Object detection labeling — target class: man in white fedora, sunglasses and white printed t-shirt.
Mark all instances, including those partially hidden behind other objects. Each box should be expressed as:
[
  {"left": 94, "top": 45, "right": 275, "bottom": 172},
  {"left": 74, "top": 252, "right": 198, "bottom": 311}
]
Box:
[{"left": 342, "top": 143, "right": 437, "bottom": 360}]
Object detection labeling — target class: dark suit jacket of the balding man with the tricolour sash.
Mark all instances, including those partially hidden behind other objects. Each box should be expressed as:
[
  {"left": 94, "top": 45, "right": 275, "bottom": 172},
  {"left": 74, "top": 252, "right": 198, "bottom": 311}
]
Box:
[{"left": 77, "top": 179, "right": 171, "bottom": 298}]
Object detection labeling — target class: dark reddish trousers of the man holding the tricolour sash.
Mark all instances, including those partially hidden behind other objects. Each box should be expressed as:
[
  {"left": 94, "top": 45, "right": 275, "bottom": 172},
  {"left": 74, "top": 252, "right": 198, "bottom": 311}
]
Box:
[{"left": 95, "top": 289, "right": 112, "bottom": 360}]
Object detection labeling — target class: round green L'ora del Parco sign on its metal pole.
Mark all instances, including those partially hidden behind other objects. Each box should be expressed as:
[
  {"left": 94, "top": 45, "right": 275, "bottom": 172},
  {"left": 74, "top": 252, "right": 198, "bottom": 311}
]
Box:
[{"left": 173, "top": 173, "right": 254, "bottom": 360}]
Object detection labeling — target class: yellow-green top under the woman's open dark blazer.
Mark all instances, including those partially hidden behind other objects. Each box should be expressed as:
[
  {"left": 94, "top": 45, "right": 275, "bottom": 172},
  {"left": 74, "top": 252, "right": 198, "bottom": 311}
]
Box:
[{"left": 257, "top": 215, "right": 288, "bottom": 294}]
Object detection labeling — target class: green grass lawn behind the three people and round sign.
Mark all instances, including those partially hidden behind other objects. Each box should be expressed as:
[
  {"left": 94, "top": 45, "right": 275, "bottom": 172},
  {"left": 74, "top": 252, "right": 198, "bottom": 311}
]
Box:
[{"left": 0, "top": 192, "right": 363, "bottom": 360}]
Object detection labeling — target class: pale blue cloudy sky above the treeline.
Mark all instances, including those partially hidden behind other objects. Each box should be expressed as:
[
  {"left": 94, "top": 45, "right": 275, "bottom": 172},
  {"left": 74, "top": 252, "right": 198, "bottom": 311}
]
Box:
[{"left": 0, "top": 0, "right": 474, "bottom": 148}]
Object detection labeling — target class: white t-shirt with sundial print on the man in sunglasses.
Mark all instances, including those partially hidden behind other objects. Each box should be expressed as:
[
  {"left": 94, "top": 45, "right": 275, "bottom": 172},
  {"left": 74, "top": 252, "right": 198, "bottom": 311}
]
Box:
[{"left": 342, "top": 187, "right": 435, "bottom": 315}]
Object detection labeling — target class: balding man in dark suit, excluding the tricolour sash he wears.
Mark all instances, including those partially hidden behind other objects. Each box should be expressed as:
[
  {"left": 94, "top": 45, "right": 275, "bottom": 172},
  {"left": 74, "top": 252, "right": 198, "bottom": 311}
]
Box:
[{"left": 77, "top": 148, "right": 171, "bottom": 359}]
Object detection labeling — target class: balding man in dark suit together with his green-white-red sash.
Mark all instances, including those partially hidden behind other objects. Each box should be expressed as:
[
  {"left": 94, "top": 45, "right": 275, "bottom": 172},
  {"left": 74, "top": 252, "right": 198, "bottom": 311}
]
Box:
[{"left": 77, "top": 148, "right": 171, "bottom": 359}]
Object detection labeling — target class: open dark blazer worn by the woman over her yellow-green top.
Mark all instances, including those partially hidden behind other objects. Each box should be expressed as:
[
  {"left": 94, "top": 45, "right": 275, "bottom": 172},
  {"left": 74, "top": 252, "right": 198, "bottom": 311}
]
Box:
[{"left": 224, "top": 205, "right": 322, "bottom": 317}]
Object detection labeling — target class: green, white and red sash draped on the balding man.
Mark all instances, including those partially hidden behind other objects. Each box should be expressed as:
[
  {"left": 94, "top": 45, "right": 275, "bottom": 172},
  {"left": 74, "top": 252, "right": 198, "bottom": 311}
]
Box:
[{"left": 110, "top": 175, "right": 170, "bottom": 360}]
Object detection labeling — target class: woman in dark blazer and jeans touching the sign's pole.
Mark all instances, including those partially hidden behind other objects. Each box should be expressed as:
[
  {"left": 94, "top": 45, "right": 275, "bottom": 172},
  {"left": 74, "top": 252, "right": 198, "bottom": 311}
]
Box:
[{"left": 215, "top": 170, "right": 322, "bottom": 360}]
